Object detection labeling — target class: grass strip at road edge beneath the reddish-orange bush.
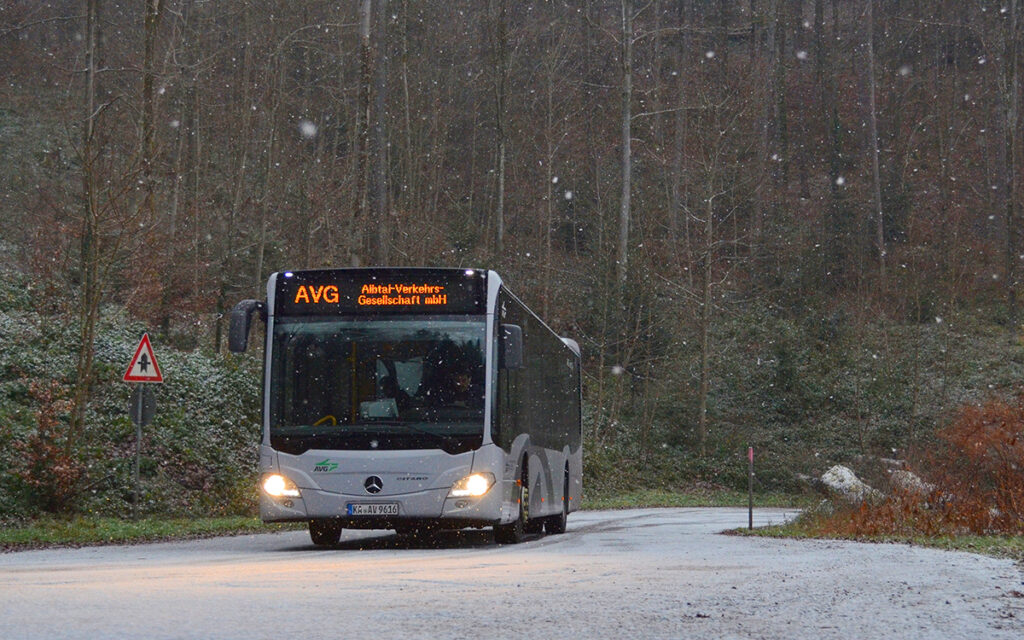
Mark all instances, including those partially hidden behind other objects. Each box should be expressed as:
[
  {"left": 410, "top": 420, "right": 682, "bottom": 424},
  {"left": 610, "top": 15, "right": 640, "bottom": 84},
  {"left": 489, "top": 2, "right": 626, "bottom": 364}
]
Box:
[{"left": 730, "top": 518, "right": 1024, "bottom": 562}]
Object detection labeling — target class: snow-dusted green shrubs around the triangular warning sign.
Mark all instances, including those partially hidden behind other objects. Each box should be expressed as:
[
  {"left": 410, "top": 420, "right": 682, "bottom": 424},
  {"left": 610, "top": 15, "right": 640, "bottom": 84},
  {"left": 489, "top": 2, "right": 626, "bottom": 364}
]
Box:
[{"left": 0, "top": 270, "right": 260, "bottom": 519}]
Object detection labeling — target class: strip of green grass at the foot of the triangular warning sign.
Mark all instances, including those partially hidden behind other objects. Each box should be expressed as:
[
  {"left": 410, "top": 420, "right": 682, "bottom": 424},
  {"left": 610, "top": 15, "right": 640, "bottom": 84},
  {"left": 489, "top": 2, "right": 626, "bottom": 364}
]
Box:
[{"left": 0, "top": 516, "right": 301, "bottom": 551}]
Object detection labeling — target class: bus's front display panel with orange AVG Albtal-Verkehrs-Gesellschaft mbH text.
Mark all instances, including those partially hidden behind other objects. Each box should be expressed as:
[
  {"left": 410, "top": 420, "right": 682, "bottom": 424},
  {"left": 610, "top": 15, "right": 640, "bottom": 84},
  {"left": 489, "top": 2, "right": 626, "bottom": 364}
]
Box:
[{"left": 274, "top": 269, "right": 486, "bottom": 315}]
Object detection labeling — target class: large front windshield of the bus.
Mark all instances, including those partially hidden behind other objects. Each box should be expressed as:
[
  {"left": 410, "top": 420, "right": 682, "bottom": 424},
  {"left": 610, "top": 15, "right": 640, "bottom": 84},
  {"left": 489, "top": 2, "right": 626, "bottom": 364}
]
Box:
[{"left": 269, "top": 316, "right": 485, "bottom": 454}]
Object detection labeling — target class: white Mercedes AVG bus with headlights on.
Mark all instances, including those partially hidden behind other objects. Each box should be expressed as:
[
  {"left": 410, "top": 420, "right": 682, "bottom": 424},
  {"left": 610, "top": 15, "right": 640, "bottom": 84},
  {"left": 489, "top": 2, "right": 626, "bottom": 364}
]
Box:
[{"left": 229, "top": 268, "right": 583, "bottom": 545}]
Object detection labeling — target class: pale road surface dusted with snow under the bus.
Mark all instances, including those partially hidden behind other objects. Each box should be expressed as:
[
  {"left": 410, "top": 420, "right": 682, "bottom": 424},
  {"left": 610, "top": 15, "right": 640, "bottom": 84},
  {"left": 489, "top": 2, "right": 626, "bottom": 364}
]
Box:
[{"left": 0, "top": 509, "right": 1024, "bottom": 640}]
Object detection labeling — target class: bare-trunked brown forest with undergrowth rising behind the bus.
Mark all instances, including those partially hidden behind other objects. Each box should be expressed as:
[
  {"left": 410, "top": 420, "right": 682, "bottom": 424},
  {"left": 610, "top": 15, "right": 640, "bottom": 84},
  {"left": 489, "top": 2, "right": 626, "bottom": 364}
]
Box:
[{"left": 0, "top": 0, "right": 1024, "bottom": 516}]
